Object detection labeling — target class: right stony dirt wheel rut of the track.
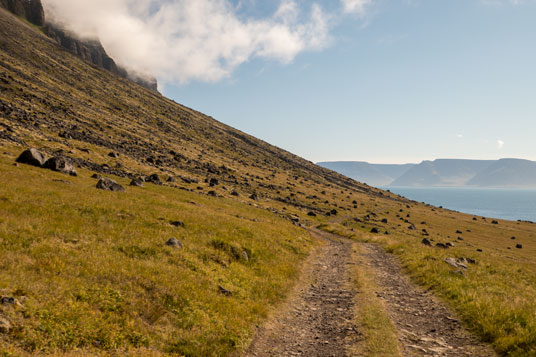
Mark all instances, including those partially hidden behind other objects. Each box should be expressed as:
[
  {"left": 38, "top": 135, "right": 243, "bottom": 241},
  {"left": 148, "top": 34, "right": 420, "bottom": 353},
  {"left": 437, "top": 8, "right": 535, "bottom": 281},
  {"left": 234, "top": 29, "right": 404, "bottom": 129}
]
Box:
[{"left": 362, "top": 244, "right": 496, "bottom": 356}]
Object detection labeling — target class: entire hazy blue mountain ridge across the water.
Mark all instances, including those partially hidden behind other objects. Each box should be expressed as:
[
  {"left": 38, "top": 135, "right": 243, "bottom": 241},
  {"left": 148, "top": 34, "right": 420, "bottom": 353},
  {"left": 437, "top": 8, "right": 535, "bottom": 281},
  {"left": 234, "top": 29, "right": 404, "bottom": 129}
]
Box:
[{"left": 318, "top": 159, "right": 536, "bottom": 188}]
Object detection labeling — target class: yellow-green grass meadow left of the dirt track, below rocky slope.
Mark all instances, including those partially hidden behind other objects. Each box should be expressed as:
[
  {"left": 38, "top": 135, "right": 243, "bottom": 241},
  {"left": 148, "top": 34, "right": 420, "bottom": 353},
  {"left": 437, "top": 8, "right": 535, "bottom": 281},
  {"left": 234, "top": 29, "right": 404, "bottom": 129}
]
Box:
[{"left": 0, "top": 157, "right": 312, "bottom": 356}]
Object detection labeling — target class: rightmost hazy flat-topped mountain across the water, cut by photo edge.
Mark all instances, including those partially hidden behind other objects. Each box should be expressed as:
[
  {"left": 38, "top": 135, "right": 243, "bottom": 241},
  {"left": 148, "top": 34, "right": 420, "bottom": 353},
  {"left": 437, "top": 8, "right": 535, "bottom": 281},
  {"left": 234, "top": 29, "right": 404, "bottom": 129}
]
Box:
[{"left": 467, "top": 159, "right": 536, "bottom": 188}]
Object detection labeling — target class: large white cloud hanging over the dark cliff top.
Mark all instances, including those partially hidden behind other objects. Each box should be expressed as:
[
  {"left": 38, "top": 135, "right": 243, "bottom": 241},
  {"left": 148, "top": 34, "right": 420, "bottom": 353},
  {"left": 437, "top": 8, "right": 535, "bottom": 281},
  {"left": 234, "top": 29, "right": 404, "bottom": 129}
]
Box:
[{"left": 43, "top": 0, "right": 329, "bottom": 83}]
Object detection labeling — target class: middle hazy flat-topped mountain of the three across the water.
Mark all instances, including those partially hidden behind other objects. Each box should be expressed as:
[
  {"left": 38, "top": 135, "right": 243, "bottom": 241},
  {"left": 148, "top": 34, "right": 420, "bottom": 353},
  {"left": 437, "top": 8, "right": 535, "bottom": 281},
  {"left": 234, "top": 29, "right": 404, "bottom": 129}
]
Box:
[{"left": 391, "top": 159, "right": 493, "bottom": 187}]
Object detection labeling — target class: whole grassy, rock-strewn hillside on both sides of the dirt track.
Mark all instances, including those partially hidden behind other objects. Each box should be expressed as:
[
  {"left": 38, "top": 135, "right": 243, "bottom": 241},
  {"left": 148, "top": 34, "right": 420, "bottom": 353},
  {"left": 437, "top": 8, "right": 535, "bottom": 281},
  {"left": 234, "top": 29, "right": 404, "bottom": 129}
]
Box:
[{"left": 0, "top": 6, "right": 536, "bottom": 356}]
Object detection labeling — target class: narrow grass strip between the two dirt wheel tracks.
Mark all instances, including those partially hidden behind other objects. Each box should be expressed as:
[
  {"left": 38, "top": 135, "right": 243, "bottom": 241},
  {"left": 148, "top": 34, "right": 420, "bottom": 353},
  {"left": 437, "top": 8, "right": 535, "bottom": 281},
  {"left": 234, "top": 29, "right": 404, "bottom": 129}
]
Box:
[{"left": 352, "top": 244, "right": 401, "bottom": 357}]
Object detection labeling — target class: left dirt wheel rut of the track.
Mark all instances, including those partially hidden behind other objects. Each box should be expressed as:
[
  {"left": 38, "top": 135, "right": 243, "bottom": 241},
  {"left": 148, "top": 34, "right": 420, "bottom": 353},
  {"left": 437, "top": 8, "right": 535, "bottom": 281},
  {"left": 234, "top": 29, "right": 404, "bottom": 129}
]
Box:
[{"left": 245, "top": 230, "right": 359, "bottom": 357}]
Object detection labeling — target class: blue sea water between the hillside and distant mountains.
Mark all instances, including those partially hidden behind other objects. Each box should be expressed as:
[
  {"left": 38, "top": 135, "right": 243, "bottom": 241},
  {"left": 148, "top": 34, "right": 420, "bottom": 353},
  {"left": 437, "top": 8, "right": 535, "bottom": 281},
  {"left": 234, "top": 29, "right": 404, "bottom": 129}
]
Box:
[{"left": 382, "top": 187, "right": 536, "bottom": 221}]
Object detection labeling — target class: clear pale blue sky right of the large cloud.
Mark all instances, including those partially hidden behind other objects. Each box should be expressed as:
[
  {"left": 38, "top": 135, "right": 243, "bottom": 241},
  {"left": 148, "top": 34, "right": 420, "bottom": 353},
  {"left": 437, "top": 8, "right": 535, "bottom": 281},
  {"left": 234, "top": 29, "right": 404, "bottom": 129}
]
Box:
[{"left": 159, "top": 0, "right": 536, "bottom": 163}]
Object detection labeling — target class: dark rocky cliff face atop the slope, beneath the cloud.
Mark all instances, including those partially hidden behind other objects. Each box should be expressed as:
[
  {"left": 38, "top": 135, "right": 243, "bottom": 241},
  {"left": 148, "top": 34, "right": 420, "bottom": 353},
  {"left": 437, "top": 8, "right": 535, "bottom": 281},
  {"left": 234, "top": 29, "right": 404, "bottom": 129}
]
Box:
[{"left": 0, "top": 0, "right": 158, "bottom": 91}]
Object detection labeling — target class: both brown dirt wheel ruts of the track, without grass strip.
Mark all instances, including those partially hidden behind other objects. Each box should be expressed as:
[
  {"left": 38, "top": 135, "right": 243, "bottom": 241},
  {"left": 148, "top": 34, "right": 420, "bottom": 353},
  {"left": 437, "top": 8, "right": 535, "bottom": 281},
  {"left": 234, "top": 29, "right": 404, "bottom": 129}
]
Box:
[{"left": 245, "top": 230, "right": 496, "bottom": 357}]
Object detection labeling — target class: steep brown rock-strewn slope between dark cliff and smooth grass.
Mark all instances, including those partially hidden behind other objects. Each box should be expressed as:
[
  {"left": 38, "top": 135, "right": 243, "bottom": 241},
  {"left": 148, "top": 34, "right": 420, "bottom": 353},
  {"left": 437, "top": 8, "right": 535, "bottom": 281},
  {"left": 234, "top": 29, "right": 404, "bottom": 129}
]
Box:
[{"left": 0, "top": 6, "right": 376, "bottom": 206}]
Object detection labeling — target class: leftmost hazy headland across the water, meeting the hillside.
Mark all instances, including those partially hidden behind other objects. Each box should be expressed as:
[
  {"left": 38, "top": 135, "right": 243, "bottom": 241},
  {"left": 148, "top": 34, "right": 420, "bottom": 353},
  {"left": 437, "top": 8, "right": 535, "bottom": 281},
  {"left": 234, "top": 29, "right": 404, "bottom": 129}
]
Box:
[{"left": 317, "top": 161, "right": 415, "bottom": 186}]
